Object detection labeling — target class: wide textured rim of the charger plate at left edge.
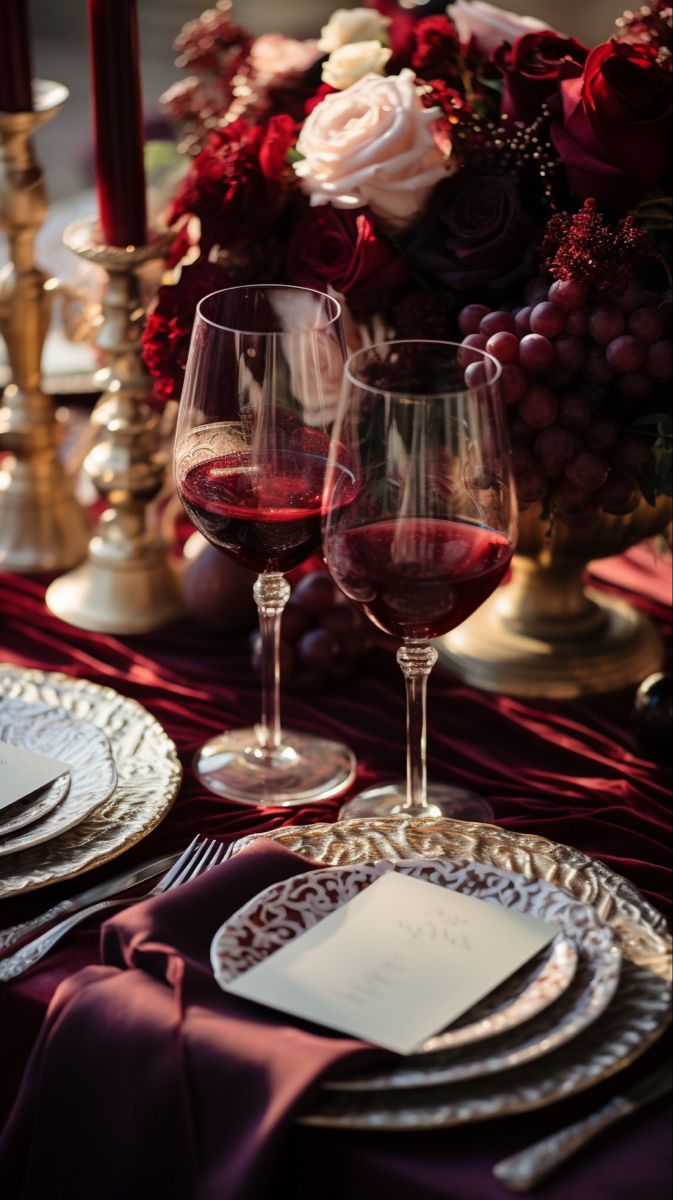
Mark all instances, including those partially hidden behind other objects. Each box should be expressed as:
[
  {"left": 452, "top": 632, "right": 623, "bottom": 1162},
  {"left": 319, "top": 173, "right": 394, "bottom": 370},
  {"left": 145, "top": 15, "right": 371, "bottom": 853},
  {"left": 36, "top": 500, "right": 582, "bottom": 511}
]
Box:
[{"left": 0, "top": 665, "right": 181, "bottom": 899}]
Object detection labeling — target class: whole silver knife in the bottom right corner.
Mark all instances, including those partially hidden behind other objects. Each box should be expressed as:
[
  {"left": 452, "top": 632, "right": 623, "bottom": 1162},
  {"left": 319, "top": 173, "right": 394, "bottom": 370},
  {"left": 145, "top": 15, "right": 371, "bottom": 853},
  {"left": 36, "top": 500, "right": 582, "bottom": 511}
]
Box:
[{"left": 493, "top": 1062, "right": 673, "bottom": 1192}]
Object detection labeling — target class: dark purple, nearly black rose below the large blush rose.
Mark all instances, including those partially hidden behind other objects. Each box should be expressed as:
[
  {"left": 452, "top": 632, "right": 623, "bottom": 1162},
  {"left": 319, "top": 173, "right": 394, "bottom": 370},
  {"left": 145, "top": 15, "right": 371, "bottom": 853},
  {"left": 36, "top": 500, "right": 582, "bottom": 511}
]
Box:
[{"left": 409, "top": 167, "right": 539, "bottom": 293}]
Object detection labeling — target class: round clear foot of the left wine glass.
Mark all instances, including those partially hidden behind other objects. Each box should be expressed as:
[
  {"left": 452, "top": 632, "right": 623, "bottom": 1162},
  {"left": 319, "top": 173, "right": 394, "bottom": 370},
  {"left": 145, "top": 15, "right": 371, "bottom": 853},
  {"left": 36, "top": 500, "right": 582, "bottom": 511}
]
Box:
[{"left": 194, "top": 728, "right": 356, "bottom": 808}]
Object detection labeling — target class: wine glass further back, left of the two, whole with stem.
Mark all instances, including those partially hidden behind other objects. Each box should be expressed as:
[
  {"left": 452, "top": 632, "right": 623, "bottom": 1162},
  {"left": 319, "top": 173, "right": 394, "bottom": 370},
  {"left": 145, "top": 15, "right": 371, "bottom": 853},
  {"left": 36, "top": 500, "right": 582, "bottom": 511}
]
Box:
[{"left": 175, "top": 284, "right": 355, "bottom": 806}]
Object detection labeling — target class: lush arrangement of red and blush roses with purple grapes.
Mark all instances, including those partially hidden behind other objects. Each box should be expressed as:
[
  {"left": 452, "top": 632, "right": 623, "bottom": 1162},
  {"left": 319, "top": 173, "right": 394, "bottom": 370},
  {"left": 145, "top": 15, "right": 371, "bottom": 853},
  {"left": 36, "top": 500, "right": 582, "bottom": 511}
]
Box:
[{"left": 144, "top": 0, "right": 673, "bottom": 528}]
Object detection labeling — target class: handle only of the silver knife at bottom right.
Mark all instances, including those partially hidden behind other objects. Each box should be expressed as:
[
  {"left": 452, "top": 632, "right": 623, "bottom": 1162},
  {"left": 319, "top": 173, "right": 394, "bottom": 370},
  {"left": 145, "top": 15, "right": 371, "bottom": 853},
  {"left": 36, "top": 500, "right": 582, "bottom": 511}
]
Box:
[{"left": 493, "top": 1096, "right": 636, "bottom": 1192}]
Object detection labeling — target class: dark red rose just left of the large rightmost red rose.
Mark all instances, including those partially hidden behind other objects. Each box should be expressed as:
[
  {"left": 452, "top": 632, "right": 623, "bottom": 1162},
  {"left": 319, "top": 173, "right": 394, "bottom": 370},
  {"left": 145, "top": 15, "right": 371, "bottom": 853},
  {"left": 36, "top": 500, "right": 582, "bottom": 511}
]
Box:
[{"left": 493, "top": 30, "right": 589, "bottom": 124}]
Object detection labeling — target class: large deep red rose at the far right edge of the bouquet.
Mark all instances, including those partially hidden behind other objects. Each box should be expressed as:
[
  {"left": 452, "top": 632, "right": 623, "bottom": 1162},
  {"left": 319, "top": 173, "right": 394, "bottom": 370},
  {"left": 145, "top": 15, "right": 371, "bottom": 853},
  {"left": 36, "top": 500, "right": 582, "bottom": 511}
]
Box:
[{"left": 552, "top": 41, "right": 673, "bottom": 210}]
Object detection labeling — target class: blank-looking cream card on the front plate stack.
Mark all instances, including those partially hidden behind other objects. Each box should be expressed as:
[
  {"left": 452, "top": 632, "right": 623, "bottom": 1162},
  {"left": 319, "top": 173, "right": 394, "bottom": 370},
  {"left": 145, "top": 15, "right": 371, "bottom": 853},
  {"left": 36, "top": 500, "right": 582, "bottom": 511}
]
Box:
[{"left": 223, "top": 870, "right": 559, "bottom": 1054}]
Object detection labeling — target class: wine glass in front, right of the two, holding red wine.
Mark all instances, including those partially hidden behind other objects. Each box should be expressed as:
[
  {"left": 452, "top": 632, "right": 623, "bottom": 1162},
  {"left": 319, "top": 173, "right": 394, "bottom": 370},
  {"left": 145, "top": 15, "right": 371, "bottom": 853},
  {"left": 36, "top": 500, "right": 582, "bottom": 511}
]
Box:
[{"left": 323, "top": 341, "right": 517, "bottom": 820}]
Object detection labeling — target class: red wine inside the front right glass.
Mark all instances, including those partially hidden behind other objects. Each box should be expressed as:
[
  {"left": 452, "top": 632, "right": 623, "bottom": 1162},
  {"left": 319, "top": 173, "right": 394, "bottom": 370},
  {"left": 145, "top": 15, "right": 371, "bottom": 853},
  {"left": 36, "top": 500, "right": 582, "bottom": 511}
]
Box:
[{"left": 330, "top": 517, "right": 512, "bottom": 640}]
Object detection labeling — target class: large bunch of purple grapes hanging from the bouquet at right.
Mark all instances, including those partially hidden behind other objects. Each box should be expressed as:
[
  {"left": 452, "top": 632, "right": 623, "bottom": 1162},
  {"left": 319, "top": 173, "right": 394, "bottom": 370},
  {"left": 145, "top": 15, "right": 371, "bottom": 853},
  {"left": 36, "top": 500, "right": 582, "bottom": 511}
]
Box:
[{"left": 458, "top": 277, "right": 673, "bottom": 529}]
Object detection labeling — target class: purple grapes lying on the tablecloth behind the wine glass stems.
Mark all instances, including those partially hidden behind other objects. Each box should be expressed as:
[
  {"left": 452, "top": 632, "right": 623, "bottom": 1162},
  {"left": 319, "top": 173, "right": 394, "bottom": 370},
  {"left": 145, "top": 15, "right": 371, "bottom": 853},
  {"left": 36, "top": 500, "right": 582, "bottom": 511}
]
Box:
[{"left": 252, "top": 571, "right": 372, "bottom": 691}]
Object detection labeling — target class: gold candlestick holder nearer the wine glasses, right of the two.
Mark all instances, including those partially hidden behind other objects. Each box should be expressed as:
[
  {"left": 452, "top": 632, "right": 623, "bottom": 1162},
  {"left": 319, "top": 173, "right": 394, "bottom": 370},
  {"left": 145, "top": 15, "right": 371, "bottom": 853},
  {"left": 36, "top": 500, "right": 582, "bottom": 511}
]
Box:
[{"left": 47, "top": 221, "right": 182, "bottom": 634}]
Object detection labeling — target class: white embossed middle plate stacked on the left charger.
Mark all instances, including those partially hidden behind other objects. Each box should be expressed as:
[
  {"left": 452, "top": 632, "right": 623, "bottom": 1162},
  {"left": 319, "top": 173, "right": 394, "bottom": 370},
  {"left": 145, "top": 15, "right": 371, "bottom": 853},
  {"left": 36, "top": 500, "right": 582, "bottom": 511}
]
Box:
[{"left": 0, "top": 697, "right": 116, "bottom": 858}]
